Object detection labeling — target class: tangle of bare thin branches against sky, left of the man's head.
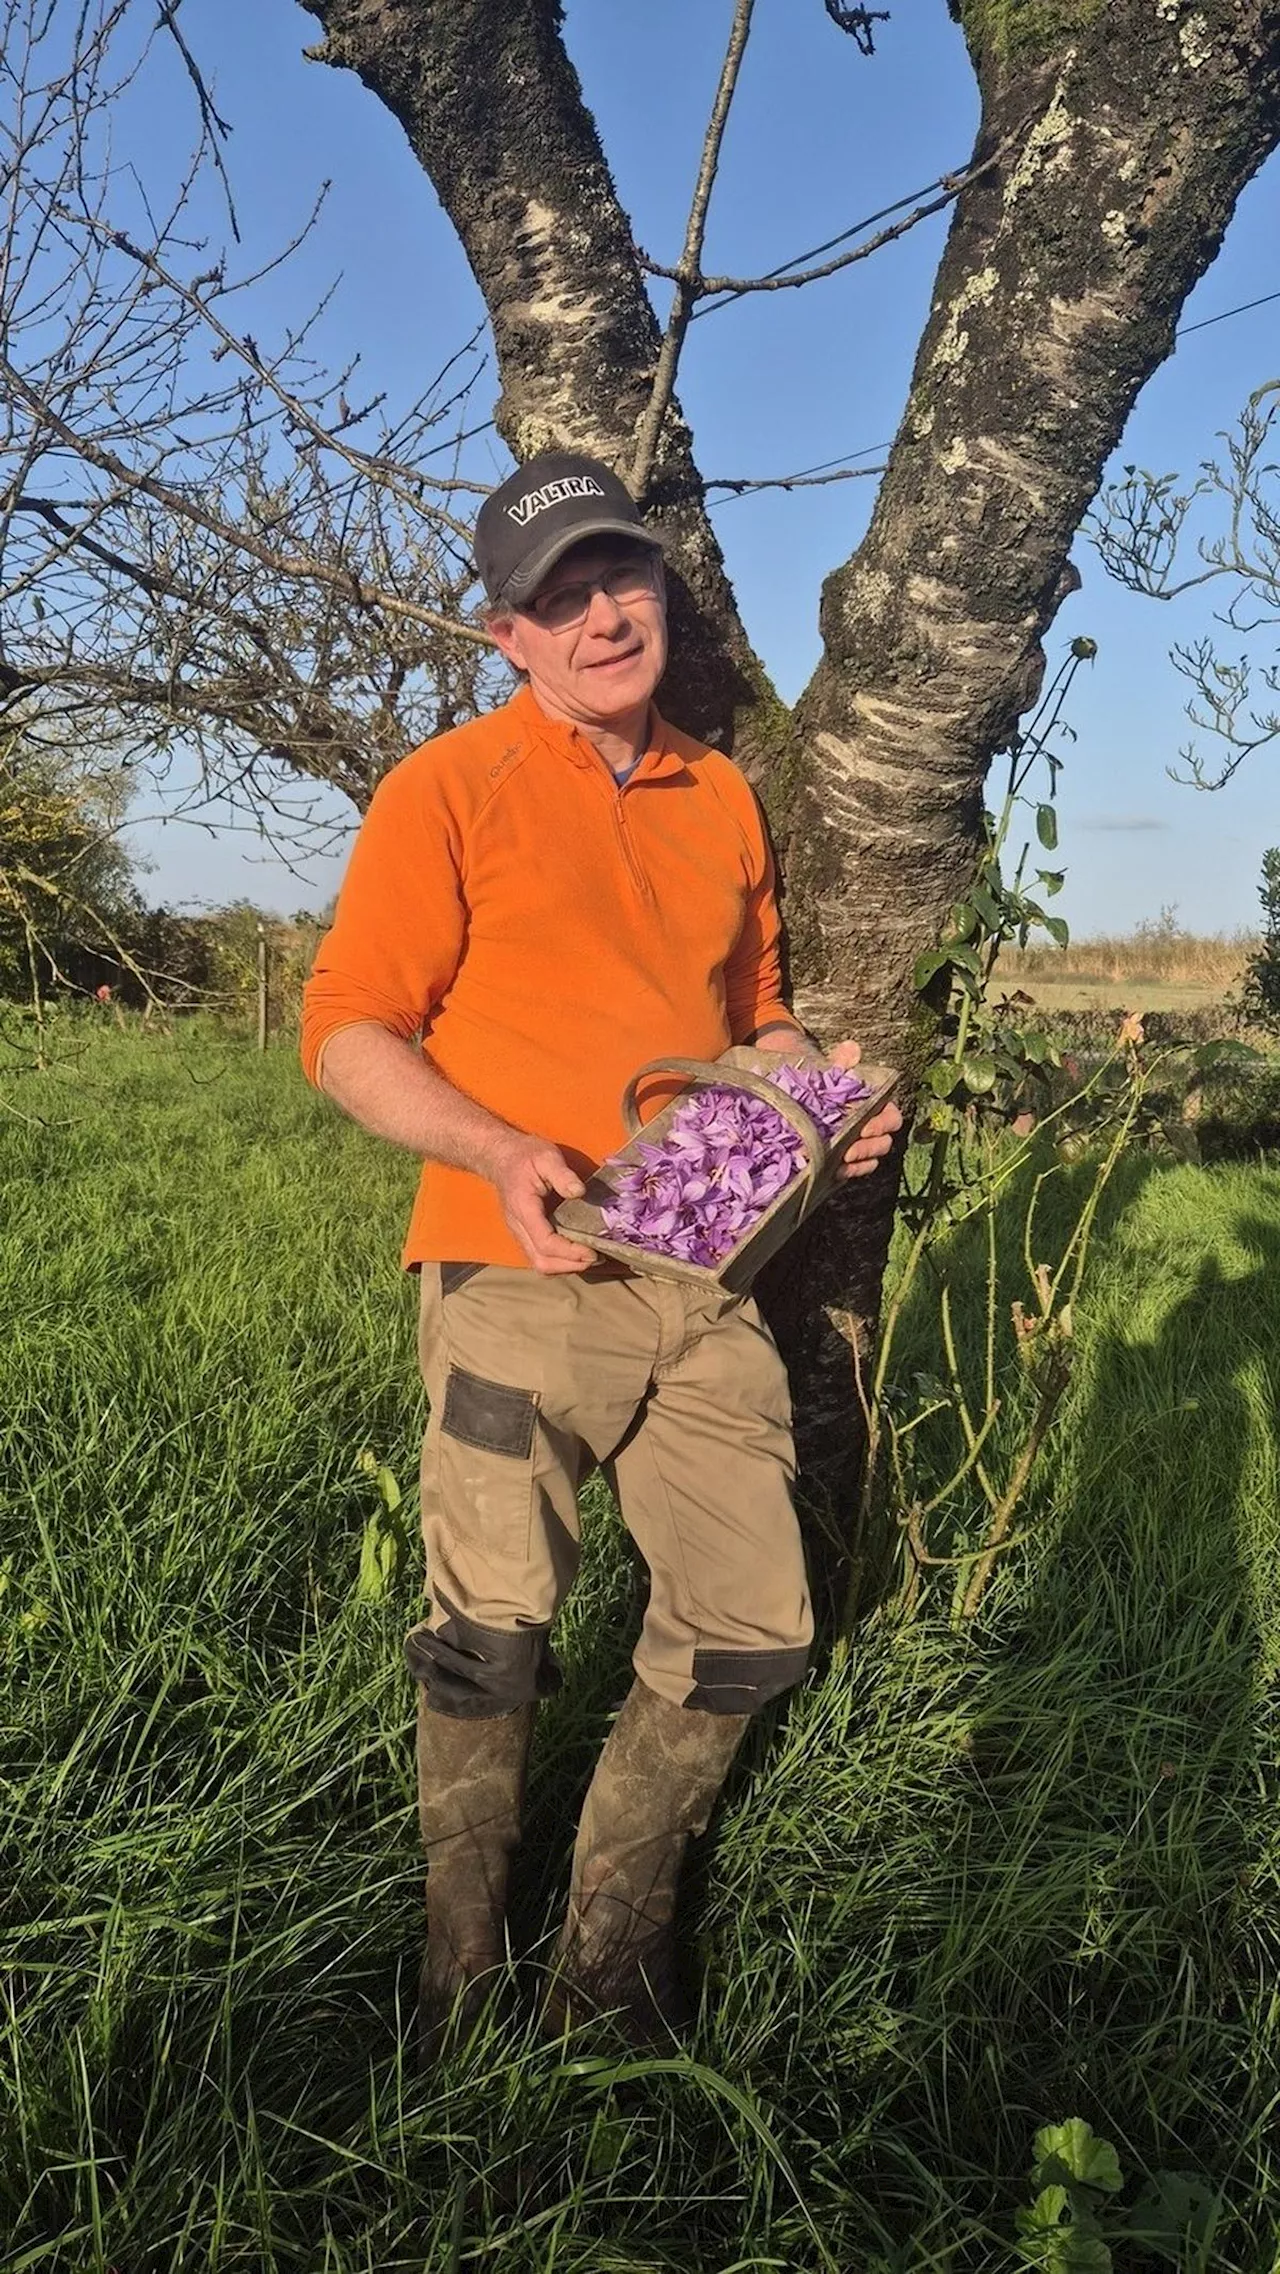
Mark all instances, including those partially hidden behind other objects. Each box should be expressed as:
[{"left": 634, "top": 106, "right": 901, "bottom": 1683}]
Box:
[{"left": 0, "top": 0, "right": 502, "bottom": 846}]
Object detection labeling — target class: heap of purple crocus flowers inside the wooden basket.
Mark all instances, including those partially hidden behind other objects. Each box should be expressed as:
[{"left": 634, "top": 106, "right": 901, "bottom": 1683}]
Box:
[{"left": 600, "top": 1064, "right": 866, "bottom": 1269}]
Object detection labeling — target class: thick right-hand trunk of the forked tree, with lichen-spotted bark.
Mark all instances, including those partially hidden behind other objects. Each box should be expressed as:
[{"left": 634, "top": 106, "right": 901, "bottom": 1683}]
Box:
[{"left": 771, "top": 0, "right": 1280, "bottom": 1582}]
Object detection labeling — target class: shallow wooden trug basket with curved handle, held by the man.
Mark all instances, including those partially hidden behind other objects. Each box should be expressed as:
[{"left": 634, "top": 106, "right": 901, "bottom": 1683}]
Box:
[{"left": 552, "top": 1044, "right": 898, "bottom": 1294}]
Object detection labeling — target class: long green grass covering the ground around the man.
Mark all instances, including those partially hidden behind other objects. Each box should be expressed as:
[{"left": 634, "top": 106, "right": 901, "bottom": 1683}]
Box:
[{"left": 0, "top": 1032, "right": 1280, "bottom": 2274}]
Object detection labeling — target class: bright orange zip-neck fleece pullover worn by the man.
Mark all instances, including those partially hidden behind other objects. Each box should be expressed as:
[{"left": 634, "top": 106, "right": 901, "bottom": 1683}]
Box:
[{"left": 302, "top": 687, "right": 789, "bottom": 1264}]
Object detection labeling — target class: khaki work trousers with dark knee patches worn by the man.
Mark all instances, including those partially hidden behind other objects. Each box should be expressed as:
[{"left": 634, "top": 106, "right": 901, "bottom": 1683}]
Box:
[{"left": 405, "top": 1264, "right": 814, "bottom": 1717}]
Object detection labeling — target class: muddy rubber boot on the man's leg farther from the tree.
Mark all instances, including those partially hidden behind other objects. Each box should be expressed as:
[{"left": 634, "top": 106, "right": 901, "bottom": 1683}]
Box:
[{"left": 418, "top": 1690, "right": 534, "bottom": 2065}]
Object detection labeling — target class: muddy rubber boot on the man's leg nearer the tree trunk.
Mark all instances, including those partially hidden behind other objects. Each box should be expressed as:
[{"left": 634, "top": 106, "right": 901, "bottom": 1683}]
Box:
[{"left": 543, "top": 1680, "right": 750, "bottom": 2049}]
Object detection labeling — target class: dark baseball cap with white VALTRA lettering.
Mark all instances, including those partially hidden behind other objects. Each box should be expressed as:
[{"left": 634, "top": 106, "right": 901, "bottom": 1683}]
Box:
[{"left": 475, "top": 450, "right": 662, "bottom": 607}]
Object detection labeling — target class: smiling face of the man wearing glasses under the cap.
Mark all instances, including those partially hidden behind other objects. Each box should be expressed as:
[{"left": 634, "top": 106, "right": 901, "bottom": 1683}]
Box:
[{"left": 489, "top": 537, "right": 666, "bottom": 725}]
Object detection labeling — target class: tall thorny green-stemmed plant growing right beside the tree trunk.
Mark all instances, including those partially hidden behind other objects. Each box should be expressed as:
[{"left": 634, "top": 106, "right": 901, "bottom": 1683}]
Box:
[{"left": 848, "top": 639, "right": 1236, "bottom": 1626}]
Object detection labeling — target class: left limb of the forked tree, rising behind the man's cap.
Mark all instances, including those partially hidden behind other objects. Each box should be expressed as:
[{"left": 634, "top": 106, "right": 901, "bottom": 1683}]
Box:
[{"left": 302, "top": 0, "right": 782, "bottom": 757}]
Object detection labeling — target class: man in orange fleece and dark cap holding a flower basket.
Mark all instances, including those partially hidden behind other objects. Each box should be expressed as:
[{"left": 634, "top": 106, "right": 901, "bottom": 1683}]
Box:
[{"left": 302, "top": 453, "right": 900, "bottom": 2044}]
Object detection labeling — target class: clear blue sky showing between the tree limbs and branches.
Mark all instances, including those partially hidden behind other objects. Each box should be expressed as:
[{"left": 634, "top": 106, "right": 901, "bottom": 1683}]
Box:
[{"left": 118, "top": 0, "right": 1280, "bottom": 932}]
